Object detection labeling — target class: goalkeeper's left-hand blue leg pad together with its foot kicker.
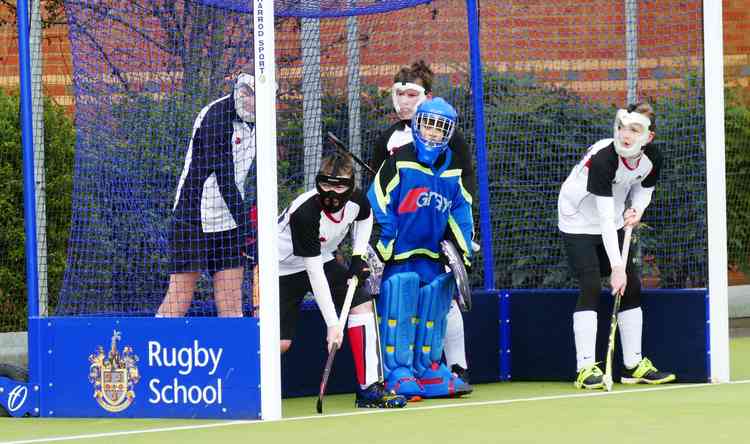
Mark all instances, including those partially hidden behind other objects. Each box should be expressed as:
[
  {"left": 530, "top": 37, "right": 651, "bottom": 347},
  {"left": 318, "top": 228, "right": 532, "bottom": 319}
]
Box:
[{"left": 378, "top": 273, "right": 424, "bottom": 397}]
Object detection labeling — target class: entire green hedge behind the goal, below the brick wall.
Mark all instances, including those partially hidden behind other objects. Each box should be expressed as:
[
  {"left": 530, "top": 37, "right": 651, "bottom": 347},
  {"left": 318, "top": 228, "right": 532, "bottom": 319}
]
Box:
[{"left": 0, "top": 72, "right": 750, "bottom": 331}]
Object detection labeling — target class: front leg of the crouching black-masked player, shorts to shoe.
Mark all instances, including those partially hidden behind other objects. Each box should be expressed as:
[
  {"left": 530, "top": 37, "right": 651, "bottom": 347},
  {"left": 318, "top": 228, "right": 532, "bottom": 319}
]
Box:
[{"left": 324, "top": 260, "right": 406, "bottom": 408}]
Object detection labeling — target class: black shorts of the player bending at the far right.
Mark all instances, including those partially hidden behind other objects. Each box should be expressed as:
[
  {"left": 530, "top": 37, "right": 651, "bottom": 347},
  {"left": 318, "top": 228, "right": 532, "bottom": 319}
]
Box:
[{"left": 562, "top": 229, "right": 639, "bottom": 279}]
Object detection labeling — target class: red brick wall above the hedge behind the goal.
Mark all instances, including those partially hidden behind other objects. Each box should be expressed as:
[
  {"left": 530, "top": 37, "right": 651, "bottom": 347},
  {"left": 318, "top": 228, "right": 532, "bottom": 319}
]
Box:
[{"left": 0, "top": 0, "right": 750, "bottom": 110}]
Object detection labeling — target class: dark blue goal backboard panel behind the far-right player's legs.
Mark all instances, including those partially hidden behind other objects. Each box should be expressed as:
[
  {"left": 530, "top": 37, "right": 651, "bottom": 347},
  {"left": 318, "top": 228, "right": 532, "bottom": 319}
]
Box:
[{"left": 510, "top": 289, "right": 709, "bottom": 382}]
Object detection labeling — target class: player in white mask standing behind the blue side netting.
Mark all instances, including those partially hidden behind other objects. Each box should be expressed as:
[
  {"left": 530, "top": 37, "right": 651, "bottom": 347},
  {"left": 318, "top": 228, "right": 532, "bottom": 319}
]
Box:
[{"left": 157, "top": 74, "right": 255, "bottom": 317}]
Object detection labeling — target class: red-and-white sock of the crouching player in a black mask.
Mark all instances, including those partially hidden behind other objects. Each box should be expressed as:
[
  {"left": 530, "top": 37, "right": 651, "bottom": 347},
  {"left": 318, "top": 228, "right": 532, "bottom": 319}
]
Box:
[{"left": 347, "top": 313, "right": 381, "bottom": 389}]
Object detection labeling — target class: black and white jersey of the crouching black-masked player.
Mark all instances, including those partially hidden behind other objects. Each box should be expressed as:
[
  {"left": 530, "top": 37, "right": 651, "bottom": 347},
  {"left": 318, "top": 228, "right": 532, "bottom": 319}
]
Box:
[{"left": 278, "top": 190, "right": 372, "bottom": 276}]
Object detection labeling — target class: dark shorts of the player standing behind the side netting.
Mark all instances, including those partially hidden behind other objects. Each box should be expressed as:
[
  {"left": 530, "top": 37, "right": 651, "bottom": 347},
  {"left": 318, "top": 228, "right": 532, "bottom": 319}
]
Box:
[{"left": 169, "top": 222, "right": 245, "bottom": 274}]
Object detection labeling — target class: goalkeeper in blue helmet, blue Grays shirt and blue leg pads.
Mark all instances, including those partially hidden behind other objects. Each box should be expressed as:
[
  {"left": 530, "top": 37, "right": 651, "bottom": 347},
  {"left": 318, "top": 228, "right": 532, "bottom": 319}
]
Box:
[{"left": 367, "top": 97, "right": 473, "bottom": 397}]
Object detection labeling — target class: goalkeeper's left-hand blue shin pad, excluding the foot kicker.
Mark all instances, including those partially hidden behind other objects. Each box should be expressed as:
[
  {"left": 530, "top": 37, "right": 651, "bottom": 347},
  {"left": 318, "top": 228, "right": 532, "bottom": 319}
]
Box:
[{"left": 378, "top": 273, "right": 419, "bottom": 376}]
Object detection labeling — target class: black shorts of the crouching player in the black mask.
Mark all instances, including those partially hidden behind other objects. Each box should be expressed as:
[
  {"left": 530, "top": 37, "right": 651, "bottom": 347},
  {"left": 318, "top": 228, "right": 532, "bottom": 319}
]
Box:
[{"left": 279, "top": 259, "right": 372, "bottom": 340}]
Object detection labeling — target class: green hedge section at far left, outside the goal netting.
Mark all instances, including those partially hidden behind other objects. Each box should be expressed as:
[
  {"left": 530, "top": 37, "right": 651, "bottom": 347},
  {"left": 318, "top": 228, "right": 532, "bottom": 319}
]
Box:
[{"left": 0, "top": 91, "right": 75, "bottom": 332}]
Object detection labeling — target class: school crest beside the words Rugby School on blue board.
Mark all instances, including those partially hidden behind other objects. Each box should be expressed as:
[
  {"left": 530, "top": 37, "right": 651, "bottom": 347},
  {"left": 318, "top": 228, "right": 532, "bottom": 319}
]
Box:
[{"left": 89, "top": 330, "right": 141, "bottom": 413}]
